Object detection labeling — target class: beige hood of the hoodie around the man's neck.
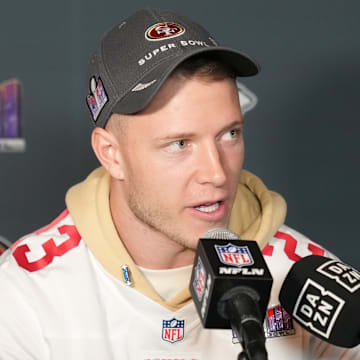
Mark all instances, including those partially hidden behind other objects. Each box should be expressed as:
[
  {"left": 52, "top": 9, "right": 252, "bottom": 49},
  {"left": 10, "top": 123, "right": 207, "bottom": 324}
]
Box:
[{"left": 66, "top": 167, "right": 286, "bottom": 311}]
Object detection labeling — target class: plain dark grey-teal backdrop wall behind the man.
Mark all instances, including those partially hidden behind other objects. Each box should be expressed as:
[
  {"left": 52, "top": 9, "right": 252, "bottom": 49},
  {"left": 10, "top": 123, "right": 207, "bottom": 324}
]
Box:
[{"left": 0, "top": 0, "right": 360, "bottom": 269}]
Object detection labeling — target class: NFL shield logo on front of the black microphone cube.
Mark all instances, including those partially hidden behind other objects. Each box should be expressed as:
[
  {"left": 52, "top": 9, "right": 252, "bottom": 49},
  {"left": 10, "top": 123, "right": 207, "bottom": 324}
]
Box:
[{"left": 215, "top": 243, "right": 254, "bottom": 267}]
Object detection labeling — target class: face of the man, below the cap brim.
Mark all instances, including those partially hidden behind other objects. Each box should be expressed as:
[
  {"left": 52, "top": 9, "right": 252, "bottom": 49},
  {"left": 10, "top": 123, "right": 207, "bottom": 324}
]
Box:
[{"left": 115, "top": 77, "right": 244, "bottom": 249}]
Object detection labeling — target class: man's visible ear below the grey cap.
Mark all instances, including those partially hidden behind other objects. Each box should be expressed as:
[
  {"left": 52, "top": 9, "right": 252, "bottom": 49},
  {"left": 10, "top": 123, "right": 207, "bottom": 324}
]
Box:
[{"left": 91, "top": 127, "right": 124, "bottom": 180}]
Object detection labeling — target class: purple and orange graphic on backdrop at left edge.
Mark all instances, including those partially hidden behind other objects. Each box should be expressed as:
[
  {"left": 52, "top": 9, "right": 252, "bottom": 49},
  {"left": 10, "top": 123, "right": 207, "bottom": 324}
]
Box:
[{"left": 2, "top": 80, "right": 21, "bottom": 138}]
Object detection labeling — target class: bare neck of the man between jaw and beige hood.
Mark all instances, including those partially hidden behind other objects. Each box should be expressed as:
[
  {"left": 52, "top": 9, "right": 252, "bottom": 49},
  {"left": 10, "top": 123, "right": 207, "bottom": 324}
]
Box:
[{"left": 110, "top": 180, "right": 195, "bottom": 269}]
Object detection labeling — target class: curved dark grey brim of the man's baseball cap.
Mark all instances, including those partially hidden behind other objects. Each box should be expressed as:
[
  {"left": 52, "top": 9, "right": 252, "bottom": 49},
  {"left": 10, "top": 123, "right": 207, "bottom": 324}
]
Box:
[{"left": 112, "top": 46, "right": 260, "bottom": 114}]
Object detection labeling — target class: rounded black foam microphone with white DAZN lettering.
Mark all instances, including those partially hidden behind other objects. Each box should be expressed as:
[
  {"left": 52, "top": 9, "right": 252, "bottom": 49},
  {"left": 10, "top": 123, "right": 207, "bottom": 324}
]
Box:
[{"left": 279, "top": 255, "right": 360, "bottom": 348}]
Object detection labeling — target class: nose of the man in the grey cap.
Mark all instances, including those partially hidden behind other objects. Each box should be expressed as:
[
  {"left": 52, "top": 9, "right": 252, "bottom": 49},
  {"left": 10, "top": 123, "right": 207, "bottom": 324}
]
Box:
[{"left": 197, "top": 143, "right": 226, "bottom": 187}]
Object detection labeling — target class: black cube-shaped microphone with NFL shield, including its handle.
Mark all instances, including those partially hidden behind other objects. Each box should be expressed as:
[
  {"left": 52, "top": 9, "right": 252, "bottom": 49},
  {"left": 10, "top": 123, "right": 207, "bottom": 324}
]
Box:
[{"left": 190, "top": 229, "right": 273, "bottom": 360}]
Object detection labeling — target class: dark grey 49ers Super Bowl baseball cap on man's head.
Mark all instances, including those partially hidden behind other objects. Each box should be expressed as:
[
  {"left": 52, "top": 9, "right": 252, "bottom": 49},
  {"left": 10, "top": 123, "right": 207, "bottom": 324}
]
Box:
[{"left": 86, "top": 8, "right": 259, "bottom": 127}]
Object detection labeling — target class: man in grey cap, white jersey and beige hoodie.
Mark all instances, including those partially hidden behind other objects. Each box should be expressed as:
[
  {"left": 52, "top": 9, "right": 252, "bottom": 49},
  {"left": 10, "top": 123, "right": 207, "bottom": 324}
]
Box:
[{"left": 0, "top": 9, "right": 355, "bottom": 360}]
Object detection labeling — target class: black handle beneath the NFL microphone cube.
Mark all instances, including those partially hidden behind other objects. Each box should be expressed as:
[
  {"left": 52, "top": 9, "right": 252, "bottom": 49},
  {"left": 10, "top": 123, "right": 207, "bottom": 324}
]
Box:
[{"left": 221, "top": 287, "right": 268, "bottom": 360}]
